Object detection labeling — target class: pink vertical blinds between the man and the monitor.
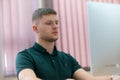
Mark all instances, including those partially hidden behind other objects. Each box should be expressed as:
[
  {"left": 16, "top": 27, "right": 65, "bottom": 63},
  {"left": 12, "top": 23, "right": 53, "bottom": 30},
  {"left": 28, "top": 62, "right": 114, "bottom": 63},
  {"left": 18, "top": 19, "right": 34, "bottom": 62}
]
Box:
[{"left": 53, "top": 0, "right": 120, "bottom": 67}]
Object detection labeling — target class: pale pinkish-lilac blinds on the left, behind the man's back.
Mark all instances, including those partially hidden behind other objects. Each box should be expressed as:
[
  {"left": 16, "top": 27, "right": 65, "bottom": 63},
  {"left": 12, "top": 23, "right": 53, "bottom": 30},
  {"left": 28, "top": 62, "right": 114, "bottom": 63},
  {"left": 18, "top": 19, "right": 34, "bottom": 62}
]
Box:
[{"left": 1, "top": 0, "right": 38, "bottom": 75}]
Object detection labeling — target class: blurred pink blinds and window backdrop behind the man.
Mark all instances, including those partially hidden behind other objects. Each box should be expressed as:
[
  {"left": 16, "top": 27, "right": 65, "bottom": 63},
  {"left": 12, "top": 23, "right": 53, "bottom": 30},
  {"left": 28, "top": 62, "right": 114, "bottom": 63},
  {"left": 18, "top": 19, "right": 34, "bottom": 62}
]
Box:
[{"left": 0, "top": 0, "right": 120, "bottom": 80}]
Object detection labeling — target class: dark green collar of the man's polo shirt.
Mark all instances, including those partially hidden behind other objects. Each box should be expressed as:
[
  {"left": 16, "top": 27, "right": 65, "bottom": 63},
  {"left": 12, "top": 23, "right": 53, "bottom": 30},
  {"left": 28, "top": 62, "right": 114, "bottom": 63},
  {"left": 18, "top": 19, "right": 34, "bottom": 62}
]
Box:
[{"left": 33, "top": 42, "right": 57, "bottom": 56}]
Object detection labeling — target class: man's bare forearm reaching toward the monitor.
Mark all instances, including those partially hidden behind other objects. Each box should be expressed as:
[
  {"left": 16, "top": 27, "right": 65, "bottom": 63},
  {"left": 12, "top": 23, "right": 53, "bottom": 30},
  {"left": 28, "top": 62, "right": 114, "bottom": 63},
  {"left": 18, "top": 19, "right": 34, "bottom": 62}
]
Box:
[{"left": 73, "top": 68, "right": 112, "bottom": 80}]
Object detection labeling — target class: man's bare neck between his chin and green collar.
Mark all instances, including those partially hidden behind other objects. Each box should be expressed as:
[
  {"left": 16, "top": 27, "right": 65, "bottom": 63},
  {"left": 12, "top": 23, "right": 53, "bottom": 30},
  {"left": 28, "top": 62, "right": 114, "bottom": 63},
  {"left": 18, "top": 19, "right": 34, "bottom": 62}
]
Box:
[{"left": 36, "top": 40, "right": 54, "bottom": 54}]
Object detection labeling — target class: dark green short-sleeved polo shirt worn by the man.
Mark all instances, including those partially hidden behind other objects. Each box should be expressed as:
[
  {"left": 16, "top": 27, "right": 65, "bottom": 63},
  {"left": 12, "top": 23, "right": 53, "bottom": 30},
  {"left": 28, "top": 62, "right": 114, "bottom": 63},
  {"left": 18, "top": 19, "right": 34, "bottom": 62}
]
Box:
[{"left": 16, "top": 43, "right": 81, "bottom": 80}]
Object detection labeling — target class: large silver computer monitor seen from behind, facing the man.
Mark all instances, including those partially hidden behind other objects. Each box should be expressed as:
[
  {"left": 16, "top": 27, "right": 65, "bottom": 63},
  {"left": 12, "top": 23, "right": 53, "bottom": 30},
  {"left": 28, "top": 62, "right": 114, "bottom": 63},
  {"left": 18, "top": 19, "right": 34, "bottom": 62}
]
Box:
[{"left": 87, "top": 2, "right": 120, "bottom": 76}]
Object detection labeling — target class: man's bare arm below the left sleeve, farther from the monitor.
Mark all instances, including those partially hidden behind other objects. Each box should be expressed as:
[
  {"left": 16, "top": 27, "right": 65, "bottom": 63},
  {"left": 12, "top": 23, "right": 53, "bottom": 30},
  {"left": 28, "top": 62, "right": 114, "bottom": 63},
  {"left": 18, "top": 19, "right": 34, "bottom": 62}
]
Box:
[{"left": 18, "top": 69, "right": 42, "bottom": 80}]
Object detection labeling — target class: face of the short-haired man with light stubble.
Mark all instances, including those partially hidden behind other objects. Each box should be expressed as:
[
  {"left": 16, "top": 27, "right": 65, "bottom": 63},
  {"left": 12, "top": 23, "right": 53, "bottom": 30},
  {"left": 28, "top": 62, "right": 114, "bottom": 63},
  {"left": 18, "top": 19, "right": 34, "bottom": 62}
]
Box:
[{"left": 38, "top": 14, "right": 58, "bottom": 42}]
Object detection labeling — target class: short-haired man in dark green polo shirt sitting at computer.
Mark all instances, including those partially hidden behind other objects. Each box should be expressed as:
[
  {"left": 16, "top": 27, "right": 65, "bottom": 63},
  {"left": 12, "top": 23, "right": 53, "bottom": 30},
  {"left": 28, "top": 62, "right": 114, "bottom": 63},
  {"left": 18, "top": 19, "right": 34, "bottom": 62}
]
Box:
[{"left": 16, "top": 8, "right": 119, "bottom": 80}]
